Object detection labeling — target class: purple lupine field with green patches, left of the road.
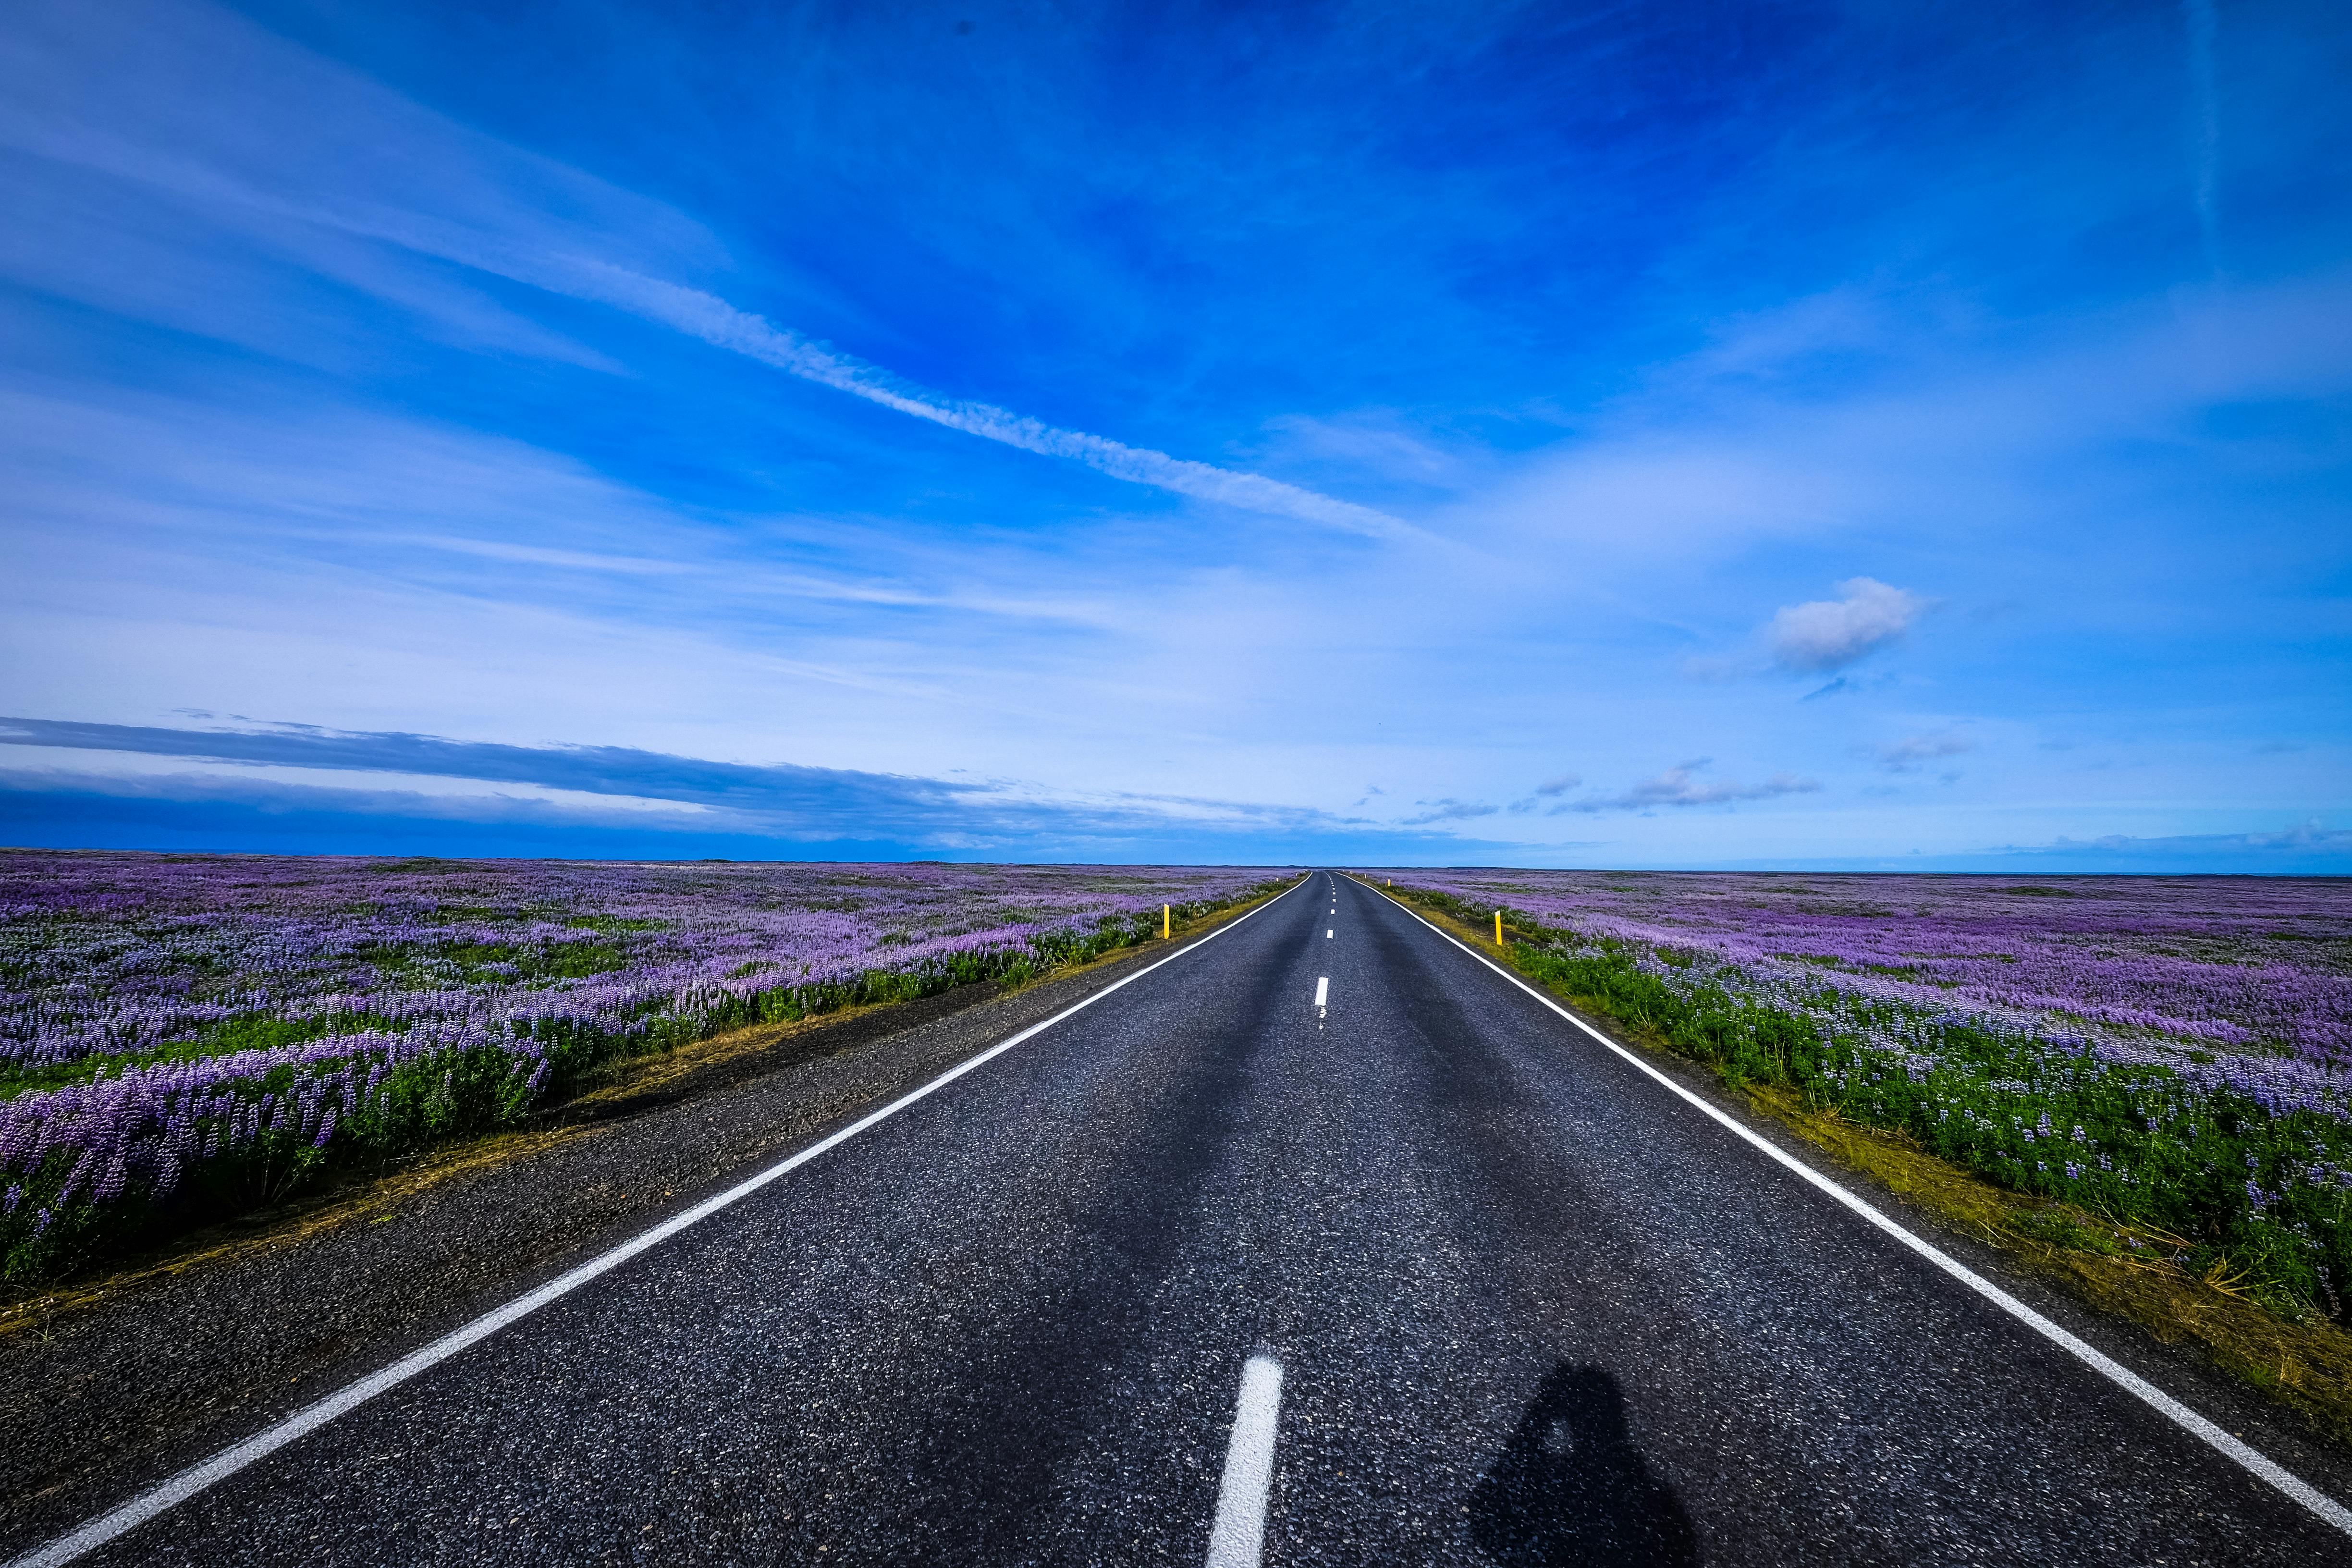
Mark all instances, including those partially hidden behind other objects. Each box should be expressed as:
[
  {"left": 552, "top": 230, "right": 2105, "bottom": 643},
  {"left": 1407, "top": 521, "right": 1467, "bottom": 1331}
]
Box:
[{"left": 0, "top": 851, "right": 1268, "bottom": 1279}]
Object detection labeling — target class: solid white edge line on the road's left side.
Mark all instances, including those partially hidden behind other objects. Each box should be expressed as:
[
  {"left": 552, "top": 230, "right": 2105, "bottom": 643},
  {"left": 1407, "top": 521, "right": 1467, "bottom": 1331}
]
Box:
[{"left": 7, "top": 884, "right": 1303, "bottom": 1568}]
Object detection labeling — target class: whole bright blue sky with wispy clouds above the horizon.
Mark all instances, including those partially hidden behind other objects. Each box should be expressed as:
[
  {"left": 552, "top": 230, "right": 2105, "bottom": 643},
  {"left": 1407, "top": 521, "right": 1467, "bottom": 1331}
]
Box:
[{"left": 0, "top": 0, "right": 2352, "bottom": 872}]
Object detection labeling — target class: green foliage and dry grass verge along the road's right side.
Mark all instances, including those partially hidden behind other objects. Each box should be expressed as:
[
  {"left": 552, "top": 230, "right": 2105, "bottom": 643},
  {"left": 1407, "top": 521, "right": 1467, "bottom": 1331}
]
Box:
[{"left": 1376, "top": 879, "right": 2352, "bottom": 1444}]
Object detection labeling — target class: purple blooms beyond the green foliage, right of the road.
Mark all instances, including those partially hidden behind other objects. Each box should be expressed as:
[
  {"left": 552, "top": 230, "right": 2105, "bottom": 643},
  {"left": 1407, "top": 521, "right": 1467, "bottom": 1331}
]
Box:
[{"left": 1373, "top": 870, "right": 2352, "bottom": 1062}]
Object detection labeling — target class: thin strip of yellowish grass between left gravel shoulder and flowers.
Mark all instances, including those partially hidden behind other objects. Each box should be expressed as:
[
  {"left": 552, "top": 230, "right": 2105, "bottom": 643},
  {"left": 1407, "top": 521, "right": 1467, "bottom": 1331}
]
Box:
[{"left": 0, "top": 879, "right": 1298, "bottom": 1337}]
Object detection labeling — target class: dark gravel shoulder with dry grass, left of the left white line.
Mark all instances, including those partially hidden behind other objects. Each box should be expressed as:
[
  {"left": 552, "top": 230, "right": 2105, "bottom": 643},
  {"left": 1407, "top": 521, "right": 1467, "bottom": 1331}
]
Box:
[{"left": 0, "top": 905, "right": 1256, "bottom": 1544}]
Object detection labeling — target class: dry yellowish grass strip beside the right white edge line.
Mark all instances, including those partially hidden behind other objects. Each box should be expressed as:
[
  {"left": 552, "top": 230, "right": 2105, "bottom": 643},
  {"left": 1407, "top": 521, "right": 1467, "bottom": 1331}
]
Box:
[{"left": 1369, "top": 882, "right": 2352, "bottom": 1446}]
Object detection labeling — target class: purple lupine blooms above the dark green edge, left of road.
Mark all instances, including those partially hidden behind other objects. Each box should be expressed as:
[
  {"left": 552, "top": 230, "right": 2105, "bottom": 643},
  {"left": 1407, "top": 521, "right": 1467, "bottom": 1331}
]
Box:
[{"left": 0, "top": 851, "right": 1265, "bottom": 1201}]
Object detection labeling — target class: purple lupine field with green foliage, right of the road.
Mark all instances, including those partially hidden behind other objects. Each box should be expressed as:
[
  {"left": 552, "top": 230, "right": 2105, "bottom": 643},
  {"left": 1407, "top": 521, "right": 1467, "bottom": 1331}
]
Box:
[{"left": 1381, "top": 870, "right": 2352, "bottom": 1319}]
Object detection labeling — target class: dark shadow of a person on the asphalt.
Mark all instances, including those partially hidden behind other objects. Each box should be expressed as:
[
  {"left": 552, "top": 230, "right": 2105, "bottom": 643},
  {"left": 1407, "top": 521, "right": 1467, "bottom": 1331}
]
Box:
[{"left": 1470, "top": 1361, "right": 1698, "bottom": 1568}]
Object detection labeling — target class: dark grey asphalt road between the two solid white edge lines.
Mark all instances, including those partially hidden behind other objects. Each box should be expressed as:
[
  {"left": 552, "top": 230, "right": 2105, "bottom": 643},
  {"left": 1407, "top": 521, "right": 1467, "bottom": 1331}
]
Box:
[{"left": 18, "top": 874, "right": 2352, "bottom": 1566}]
